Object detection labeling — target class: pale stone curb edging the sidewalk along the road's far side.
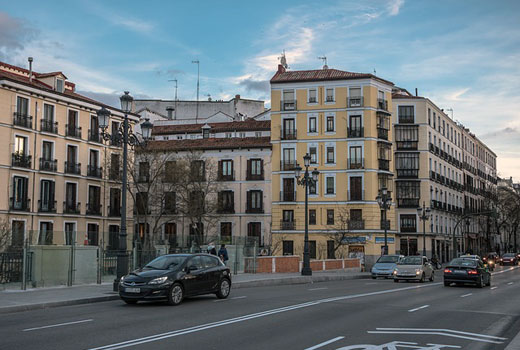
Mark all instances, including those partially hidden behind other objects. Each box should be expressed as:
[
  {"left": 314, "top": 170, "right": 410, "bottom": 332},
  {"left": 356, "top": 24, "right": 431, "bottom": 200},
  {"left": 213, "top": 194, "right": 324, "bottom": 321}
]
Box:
[{"left": 0, "top": 273, "right": 370, "bottom": 314}]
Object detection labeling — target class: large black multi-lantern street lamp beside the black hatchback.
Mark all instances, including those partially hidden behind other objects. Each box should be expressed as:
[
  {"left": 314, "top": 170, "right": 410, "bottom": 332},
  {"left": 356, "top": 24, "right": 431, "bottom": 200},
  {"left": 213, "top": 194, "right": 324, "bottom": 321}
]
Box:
[{"left": 97, "top": 91, "right": 152, "bottom": 291}]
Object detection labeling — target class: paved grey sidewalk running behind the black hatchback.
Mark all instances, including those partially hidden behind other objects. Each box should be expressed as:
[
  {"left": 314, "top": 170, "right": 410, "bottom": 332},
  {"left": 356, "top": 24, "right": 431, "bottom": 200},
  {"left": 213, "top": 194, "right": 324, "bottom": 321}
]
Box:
[{"left": 0, "top": 270, "right": 370, "bottom": 314}]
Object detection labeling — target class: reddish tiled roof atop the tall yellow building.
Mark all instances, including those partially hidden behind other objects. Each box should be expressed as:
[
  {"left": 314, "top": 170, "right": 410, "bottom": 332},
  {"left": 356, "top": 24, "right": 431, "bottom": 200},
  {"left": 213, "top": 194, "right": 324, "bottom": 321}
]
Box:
[{"left": 271, "top": 69, "right": 394, "bottom": 85}]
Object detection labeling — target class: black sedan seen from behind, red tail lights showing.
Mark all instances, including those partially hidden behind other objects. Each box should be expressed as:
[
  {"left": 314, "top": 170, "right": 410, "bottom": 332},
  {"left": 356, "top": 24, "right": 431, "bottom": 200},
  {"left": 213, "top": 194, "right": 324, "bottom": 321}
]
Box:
[{"left": 444, "top": 258, "right": 491, "bottom": 288}]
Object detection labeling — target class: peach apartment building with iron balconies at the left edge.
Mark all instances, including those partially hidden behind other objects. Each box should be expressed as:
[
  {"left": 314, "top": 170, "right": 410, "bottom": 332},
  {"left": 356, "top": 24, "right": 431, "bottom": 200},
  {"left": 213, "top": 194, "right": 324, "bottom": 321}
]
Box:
[{"left": 0, "top": 62, "right": 138, "bottom": 249}]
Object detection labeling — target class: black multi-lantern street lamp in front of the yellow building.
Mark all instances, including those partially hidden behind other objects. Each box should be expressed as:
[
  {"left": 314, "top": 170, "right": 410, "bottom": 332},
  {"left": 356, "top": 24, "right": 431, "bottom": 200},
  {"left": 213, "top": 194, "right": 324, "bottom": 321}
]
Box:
[{"left": 294, "top": 153, "right": 320, "bottom": 276}]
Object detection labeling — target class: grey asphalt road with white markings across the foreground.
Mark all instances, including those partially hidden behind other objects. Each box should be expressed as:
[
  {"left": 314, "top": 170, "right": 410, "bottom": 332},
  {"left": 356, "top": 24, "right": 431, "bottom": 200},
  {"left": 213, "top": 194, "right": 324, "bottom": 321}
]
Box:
[{"left": 0, "top": 267, "right": 520, "bottom": 350}]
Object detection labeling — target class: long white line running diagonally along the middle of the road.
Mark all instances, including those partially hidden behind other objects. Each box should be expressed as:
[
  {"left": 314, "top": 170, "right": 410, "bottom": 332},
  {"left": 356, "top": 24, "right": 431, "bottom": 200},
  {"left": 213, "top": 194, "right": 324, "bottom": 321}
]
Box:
[{"left": 89, "top": 282, "right": 442, "bottom": 350}]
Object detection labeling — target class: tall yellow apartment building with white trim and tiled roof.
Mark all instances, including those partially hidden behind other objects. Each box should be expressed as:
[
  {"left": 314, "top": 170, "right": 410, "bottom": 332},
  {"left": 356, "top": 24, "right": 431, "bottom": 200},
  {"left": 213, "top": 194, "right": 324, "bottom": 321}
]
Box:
[{"left": 271, "top": 65, "right": 395, "bottom": 267}]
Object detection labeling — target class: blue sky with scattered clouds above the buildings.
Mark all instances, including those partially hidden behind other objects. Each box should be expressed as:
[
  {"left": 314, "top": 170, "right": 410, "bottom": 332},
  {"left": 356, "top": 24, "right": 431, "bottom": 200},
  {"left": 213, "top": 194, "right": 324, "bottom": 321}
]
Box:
[{"left": 0, "top": 0, "right": 520, "bottom": 182}]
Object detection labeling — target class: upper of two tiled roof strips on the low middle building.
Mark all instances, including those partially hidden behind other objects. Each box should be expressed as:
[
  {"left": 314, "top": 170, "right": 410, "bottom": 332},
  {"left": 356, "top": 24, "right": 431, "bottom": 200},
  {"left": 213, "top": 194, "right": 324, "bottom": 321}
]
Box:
[{"left": 152, "top": 119, "right": 271, "bottom": 135}]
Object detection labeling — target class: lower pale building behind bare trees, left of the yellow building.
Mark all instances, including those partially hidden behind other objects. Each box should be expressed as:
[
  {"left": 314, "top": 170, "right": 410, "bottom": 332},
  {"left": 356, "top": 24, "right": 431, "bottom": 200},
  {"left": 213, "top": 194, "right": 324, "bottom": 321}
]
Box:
[{"left": 134, "top": 116, "right": 271, "bottom": 251}]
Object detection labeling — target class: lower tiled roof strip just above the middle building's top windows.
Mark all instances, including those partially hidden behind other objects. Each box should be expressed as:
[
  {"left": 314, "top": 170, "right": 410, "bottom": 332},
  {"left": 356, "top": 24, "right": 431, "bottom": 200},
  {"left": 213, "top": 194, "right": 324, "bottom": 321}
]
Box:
[{"left": 146, "top": 136, "right": 271, "bottom": 151}]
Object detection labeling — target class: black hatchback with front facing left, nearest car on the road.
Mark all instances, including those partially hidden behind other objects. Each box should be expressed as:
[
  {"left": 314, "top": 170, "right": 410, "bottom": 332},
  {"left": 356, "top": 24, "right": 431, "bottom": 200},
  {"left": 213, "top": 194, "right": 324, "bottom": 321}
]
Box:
[{"left": 119, "top": 254, "right": 231, "bottom": 305}]
